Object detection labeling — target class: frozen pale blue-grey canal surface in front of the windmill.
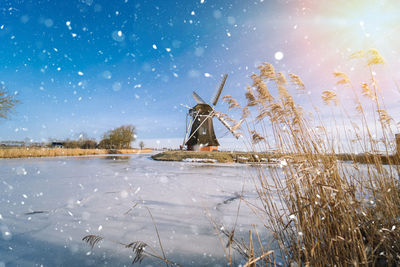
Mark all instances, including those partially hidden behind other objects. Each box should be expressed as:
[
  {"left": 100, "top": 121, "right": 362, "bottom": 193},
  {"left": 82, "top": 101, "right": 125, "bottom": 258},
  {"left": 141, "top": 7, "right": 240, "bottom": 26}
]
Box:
[{"left": 0, "top": 155, "right": 266, "bottom": 267}]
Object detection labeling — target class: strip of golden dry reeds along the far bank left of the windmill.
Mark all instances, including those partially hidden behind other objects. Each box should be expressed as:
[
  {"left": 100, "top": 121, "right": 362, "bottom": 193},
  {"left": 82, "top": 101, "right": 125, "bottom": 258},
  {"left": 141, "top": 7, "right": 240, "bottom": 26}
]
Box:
[{"left": 0, "top": 147, "right": 153, "bottom": 159}]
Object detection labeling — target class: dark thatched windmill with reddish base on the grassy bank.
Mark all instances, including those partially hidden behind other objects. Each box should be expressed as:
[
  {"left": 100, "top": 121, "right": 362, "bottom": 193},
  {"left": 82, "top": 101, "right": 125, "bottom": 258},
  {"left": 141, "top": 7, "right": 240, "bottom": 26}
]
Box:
[{"left": 183, "top": 74, "right": 240, "bottom": 151}]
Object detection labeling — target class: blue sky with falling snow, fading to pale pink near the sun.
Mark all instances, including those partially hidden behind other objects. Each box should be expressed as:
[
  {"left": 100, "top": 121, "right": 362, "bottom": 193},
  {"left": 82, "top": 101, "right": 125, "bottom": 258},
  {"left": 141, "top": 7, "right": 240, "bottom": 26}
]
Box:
[{"left": 0, "top": 0, "right": 398, "bottom": 147}]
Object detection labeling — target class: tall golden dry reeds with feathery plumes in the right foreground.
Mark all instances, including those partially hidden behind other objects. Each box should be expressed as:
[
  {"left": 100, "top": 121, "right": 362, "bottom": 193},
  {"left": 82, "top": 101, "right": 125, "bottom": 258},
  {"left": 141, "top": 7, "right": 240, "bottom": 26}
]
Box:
[{"left": 226, "top": 50, "right": 400, "bottom": 266}]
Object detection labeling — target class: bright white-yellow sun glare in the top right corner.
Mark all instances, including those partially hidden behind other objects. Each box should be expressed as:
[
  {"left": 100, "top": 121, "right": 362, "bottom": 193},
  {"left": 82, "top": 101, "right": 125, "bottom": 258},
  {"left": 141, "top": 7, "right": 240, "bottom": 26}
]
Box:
[{"left": 310, "top": 0, "right": 400, "bottom": 55}]
